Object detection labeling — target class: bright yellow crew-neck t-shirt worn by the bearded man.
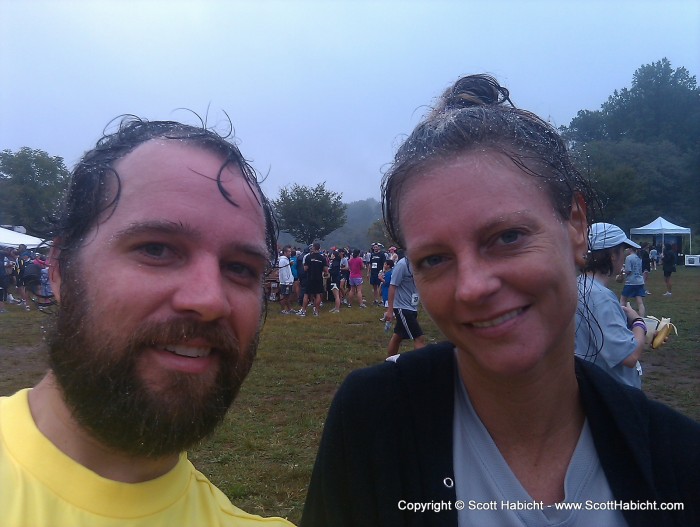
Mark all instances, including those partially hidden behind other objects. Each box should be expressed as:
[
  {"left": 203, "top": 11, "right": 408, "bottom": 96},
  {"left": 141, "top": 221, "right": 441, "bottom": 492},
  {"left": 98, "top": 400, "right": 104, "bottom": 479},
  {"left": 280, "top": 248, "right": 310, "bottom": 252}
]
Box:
[{"left": 0, "top": 390, "right": 293, "bottom": 527}]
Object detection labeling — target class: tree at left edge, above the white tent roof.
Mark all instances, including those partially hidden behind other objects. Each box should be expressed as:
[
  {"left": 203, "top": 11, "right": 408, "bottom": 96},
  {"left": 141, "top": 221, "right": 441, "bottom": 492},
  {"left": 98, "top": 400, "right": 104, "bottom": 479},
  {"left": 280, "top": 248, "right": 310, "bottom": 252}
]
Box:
[{"left": 0, "top": 147, "right": 70, "bottom": 235}]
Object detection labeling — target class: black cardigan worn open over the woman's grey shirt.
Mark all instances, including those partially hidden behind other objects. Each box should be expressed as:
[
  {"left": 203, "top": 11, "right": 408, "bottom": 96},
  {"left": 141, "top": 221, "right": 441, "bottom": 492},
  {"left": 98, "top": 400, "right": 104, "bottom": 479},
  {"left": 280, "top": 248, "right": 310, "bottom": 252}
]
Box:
[{"left": 301, "top": 343, "right": 700, "bottom": 527}]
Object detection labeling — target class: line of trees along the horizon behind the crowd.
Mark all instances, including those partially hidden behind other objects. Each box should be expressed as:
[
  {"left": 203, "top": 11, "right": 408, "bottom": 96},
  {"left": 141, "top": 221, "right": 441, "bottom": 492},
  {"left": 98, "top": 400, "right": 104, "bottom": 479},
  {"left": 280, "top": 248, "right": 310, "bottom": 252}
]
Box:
[{"left": 0, "top": 58, "right": 700, "bottom": 247}]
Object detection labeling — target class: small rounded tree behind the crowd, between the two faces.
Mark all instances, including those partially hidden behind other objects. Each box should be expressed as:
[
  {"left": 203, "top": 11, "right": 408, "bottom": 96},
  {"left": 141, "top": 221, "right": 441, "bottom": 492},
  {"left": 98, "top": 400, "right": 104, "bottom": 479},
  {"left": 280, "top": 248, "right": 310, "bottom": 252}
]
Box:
[{"left": 273, "top": 181, "right": 346, "bottom": 245}]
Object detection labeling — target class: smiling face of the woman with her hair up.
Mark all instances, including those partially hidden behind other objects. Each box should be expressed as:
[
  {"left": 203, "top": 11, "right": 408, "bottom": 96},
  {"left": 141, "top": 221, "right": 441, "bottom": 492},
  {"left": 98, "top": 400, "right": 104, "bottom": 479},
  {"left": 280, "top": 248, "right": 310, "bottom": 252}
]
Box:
[{"left": 399, "top": 152, "right": 587, "bottom": 375}]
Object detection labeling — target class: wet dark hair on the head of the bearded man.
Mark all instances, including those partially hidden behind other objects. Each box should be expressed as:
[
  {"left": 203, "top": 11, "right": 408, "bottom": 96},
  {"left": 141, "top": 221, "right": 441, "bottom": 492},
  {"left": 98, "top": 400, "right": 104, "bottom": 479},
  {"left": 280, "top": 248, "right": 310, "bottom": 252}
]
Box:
[{"left": 52, "top": 115, "right": 278, "bottom": 272}]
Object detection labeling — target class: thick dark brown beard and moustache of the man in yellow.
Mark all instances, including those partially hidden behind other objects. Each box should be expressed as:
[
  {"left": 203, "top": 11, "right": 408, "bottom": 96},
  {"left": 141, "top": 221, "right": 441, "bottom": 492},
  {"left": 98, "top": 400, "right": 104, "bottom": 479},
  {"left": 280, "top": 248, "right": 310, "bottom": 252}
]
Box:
[{"left": 48, "top": 270, "right": 259, "bottom": 458}]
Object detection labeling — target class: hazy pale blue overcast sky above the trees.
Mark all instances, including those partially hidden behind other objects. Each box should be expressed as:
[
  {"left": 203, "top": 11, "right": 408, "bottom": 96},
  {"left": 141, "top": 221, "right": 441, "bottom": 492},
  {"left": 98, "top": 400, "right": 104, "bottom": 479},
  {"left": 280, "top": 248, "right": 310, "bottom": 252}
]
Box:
[{"left": 0, "top": 0, "right": 700, "bottom": 202}]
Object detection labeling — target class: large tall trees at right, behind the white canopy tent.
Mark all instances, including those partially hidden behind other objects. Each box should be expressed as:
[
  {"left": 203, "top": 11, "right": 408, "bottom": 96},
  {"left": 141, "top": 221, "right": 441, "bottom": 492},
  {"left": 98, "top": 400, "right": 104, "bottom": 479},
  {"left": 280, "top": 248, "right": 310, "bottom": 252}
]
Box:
[{"left": 561, "top": 58, "right": 700, "bottom": 236}]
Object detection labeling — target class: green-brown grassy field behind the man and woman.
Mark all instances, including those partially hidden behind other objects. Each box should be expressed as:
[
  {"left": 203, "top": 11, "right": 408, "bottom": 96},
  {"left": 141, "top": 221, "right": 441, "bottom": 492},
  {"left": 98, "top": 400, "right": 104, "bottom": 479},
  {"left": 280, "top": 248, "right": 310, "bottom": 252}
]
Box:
[{"left": 0, "top": 267, "right": 700, "bottom": 523}]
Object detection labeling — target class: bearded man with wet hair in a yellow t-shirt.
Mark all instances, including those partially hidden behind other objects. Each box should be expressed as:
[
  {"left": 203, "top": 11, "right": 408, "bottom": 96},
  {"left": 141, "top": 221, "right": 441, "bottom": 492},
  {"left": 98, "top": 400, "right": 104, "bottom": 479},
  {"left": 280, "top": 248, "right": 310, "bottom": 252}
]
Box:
[{"left": 0, "top": 118, "right": 291, "bottom": 527}]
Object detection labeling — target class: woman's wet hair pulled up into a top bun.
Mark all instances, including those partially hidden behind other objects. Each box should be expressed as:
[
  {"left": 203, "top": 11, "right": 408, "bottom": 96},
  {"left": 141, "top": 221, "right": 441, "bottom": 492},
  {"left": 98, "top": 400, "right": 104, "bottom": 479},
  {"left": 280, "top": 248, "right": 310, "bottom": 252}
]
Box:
[{"left": 382, "top": 75, "right": 599, "bottom": 246}]
